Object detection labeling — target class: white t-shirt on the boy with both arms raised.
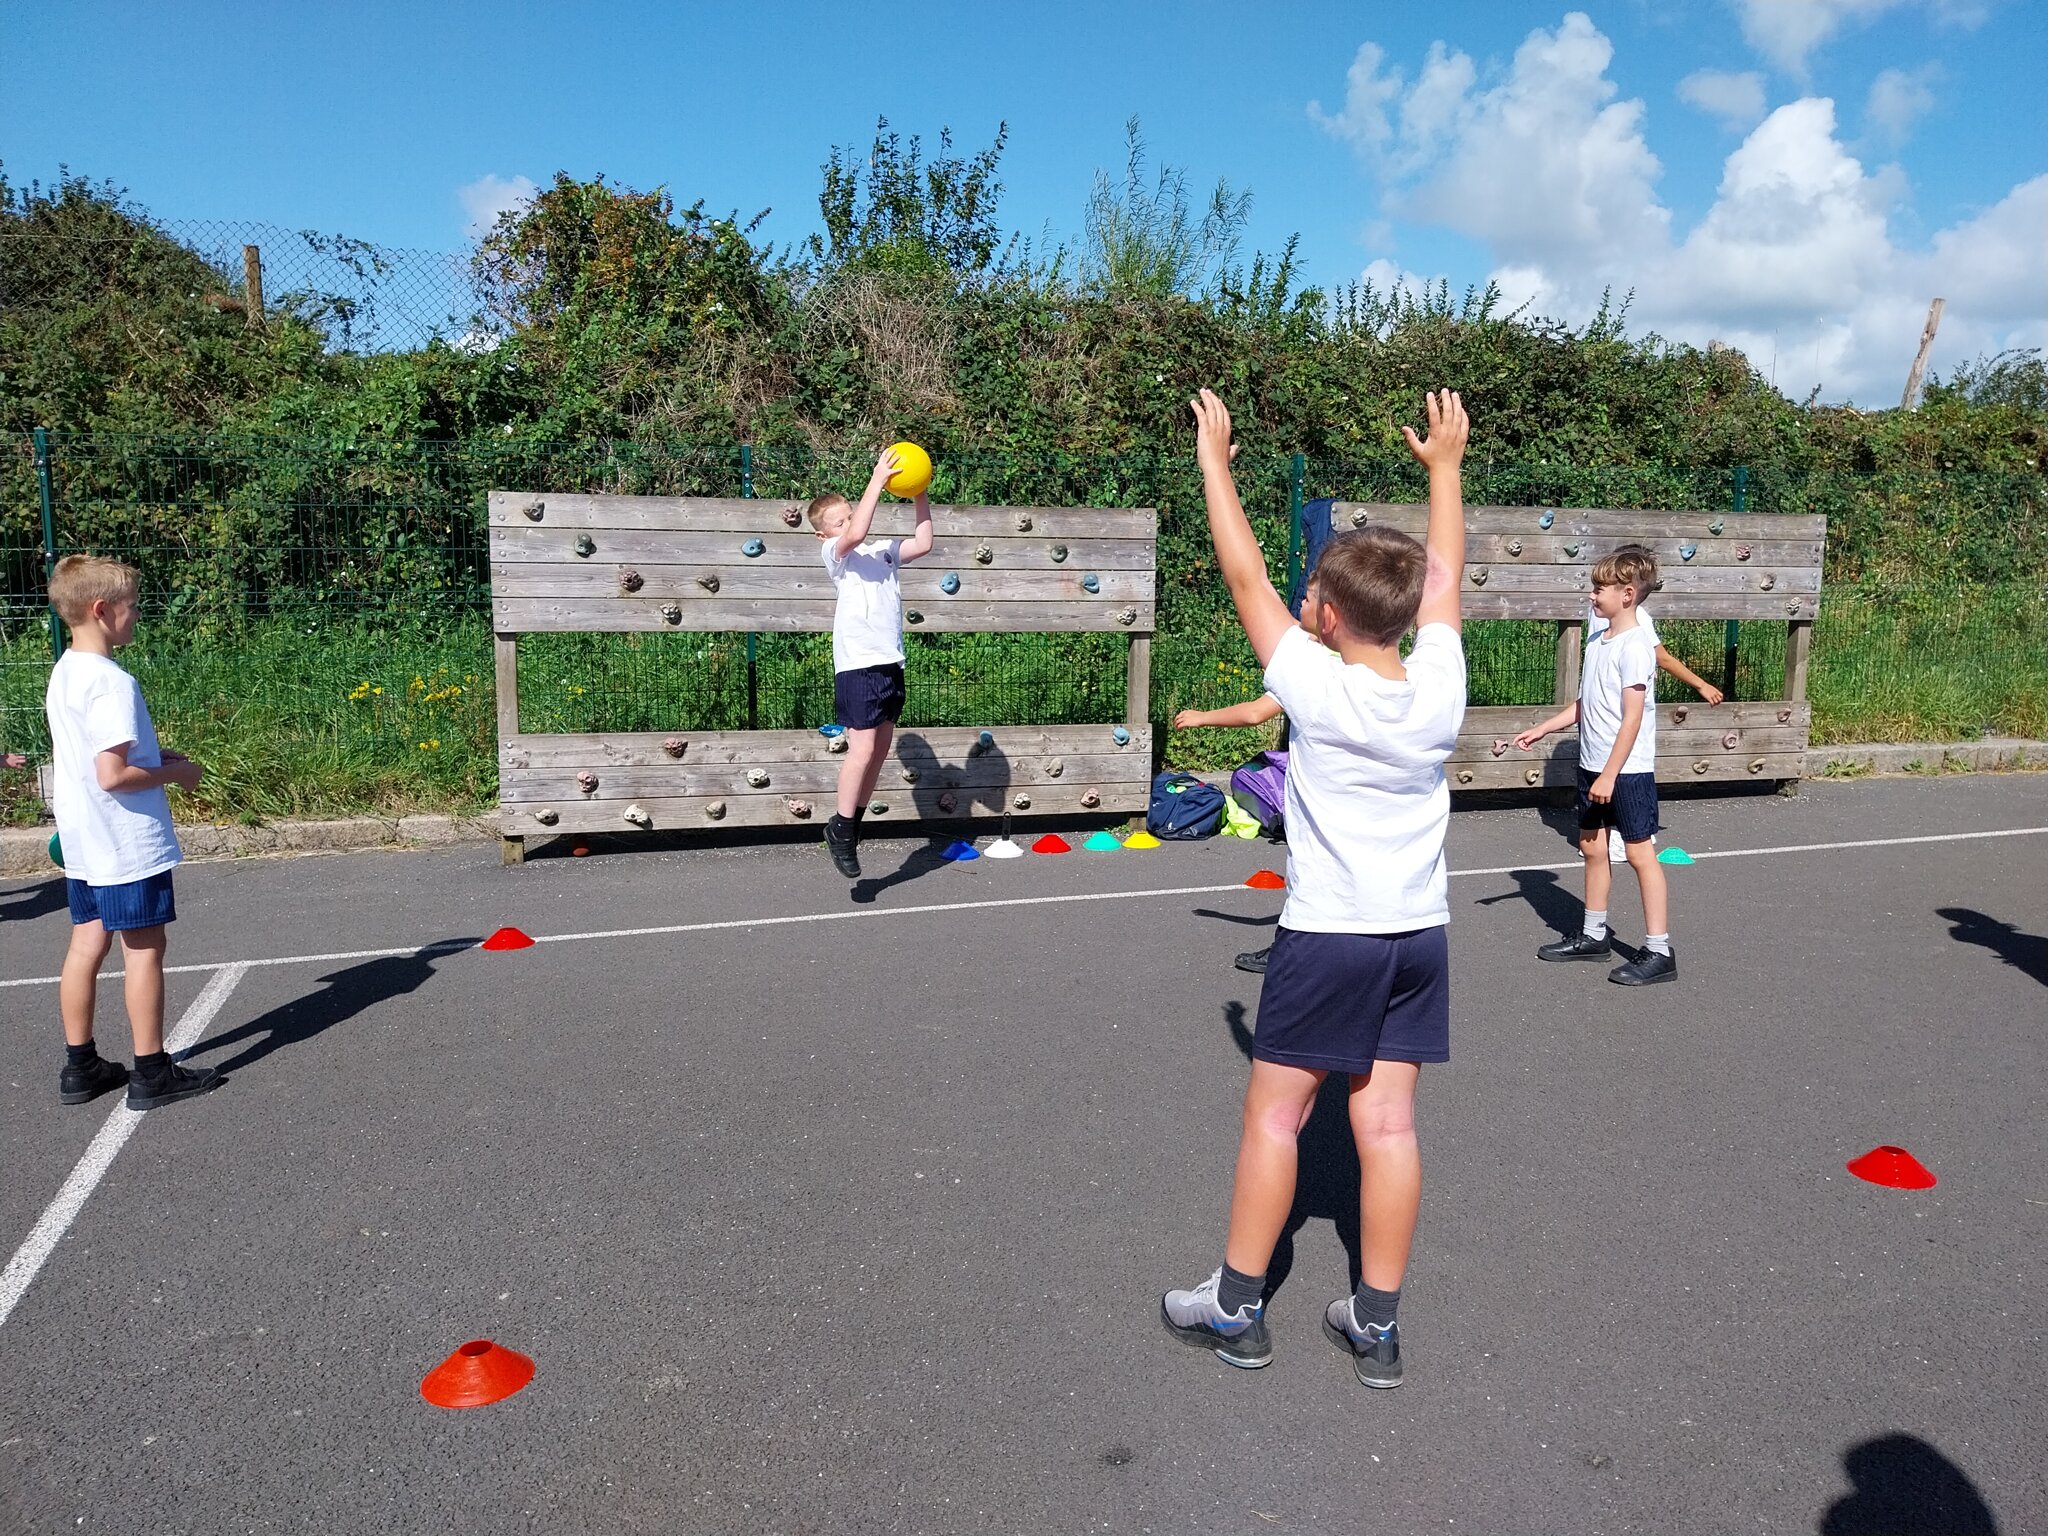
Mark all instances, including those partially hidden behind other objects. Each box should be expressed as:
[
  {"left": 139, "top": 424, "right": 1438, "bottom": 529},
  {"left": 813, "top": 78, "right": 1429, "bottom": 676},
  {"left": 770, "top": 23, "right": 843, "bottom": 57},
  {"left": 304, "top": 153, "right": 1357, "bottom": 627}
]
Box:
[{"left": 1266, "top": 625, "right": 1464, "bottom": 934}]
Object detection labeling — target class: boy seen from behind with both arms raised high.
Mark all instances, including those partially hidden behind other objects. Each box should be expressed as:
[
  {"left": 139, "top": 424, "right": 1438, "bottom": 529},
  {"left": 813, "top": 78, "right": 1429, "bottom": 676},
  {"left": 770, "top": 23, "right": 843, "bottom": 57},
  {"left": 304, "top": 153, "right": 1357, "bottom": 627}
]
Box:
[{"left": 1161, "top": 389, "right": 1470, "bottom": 1386}]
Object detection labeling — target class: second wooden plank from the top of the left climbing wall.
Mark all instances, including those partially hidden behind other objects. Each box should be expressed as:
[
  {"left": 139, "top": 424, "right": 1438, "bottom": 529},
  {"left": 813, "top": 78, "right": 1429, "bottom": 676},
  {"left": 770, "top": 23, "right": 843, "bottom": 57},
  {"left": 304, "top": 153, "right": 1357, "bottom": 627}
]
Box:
[{"left": 492, "top": 526, "right": 1155, "bottom": 575}]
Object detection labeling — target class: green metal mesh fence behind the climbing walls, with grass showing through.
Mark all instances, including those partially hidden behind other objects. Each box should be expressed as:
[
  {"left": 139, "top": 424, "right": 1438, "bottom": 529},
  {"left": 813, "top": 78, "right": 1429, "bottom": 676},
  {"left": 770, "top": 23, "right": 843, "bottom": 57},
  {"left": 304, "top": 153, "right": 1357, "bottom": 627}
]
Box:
[{"left": 0, "top": 432, "right": 2048, "bottom": 821}]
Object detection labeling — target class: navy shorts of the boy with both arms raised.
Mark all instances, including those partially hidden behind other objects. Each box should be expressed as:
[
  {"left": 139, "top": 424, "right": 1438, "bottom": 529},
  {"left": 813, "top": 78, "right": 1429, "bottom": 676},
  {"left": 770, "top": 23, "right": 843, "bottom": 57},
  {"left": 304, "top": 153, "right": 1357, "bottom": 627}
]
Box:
[{"left": 1251, "top": 928, "right": 1450, "bottom": 1077}]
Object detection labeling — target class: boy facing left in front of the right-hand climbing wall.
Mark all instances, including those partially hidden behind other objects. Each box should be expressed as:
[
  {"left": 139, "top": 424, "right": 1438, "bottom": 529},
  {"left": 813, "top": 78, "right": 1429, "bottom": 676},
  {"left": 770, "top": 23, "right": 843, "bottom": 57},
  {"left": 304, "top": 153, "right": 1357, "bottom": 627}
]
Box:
[{"left": 1516, "top": 545, "right": 1677, "bottom": 987}]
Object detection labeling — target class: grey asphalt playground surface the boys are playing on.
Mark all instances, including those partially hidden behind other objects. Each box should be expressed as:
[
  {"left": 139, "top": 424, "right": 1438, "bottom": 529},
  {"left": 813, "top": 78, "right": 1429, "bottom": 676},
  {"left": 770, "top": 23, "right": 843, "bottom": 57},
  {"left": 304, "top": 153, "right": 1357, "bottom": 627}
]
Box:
[{"left": 0, "top": 774, "right": 2048, "bottom": 1536}]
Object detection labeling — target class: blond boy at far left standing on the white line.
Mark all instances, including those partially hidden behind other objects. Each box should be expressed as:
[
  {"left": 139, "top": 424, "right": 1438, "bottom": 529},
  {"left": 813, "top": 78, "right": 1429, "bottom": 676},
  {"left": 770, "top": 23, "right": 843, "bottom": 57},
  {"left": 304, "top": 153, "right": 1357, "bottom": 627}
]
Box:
[{"left": 43, "top": 555, "right": 221, "bottom": 1110}]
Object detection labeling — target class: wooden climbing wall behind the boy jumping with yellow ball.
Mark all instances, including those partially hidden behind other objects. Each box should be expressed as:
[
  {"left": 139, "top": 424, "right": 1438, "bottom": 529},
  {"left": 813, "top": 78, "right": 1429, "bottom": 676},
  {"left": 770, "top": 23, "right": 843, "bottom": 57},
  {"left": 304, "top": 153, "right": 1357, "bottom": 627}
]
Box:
[{"left": 489, "top": 492, "right": 1157, "bottom": 860}]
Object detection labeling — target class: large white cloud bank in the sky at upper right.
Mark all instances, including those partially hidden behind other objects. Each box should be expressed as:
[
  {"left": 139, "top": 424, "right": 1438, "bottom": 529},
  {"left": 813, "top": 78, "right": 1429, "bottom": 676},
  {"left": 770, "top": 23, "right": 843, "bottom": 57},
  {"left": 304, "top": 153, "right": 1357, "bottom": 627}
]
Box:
[{"left": 1311, "top": 6, "right": 2048, "bottom": 406}]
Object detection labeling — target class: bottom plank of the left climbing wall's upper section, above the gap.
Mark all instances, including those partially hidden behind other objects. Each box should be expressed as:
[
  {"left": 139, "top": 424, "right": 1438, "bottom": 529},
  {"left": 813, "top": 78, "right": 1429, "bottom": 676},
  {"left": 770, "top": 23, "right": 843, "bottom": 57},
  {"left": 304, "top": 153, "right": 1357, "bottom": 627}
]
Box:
[{"left": 492, "top": 594, "right": 1153, "bottom": 635}]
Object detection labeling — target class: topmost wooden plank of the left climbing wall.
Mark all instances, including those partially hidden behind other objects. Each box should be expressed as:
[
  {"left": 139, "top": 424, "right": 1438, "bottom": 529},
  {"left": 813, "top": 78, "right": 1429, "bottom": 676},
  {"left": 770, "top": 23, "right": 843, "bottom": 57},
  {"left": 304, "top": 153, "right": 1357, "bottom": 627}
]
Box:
[{"left": 489, "top": 492, "right": 1159, "bottom": 541}]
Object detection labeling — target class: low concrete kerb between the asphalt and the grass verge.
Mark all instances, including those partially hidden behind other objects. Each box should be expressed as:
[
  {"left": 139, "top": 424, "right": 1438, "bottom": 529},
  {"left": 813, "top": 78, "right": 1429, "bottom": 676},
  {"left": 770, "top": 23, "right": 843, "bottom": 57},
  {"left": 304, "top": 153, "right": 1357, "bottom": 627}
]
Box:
[{"left": 0, "top": 735, "right": 2048, "bottom": 879}]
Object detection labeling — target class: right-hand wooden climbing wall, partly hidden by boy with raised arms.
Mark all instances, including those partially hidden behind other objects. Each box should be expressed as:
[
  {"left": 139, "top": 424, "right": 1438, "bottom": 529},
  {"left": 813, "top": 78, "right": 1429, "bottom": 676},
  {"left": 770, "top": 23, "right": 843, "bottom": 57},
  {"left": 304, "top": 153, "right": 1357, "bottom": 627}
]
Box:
[{"left": 1331, "top": 502, "right": 1827, "bottom": 788}]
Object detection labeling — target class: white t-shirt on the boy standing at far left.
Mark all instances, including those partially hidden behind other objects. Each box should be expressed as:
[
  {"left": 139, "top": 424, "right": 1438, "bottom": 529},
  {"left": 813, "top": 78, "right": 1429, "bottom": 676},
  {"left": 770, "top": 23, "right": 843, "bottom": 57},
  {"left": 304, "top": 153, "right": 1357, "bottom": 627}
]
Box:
[{"left": 43, "top": 649, "right": 184, "bottom": 885}]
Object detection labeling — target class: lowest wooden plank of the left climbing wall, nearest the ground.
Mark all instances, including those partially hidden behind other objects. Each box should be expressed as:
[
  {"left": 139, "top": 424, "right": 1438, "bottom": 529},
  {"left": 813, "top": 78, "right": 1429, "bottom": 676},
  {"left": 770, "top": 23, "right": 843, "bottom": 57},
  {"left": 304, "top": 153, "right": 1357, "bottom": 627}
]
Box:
[{"left": 498, "top": 778, "right": 1151, "bottom": 838}]
